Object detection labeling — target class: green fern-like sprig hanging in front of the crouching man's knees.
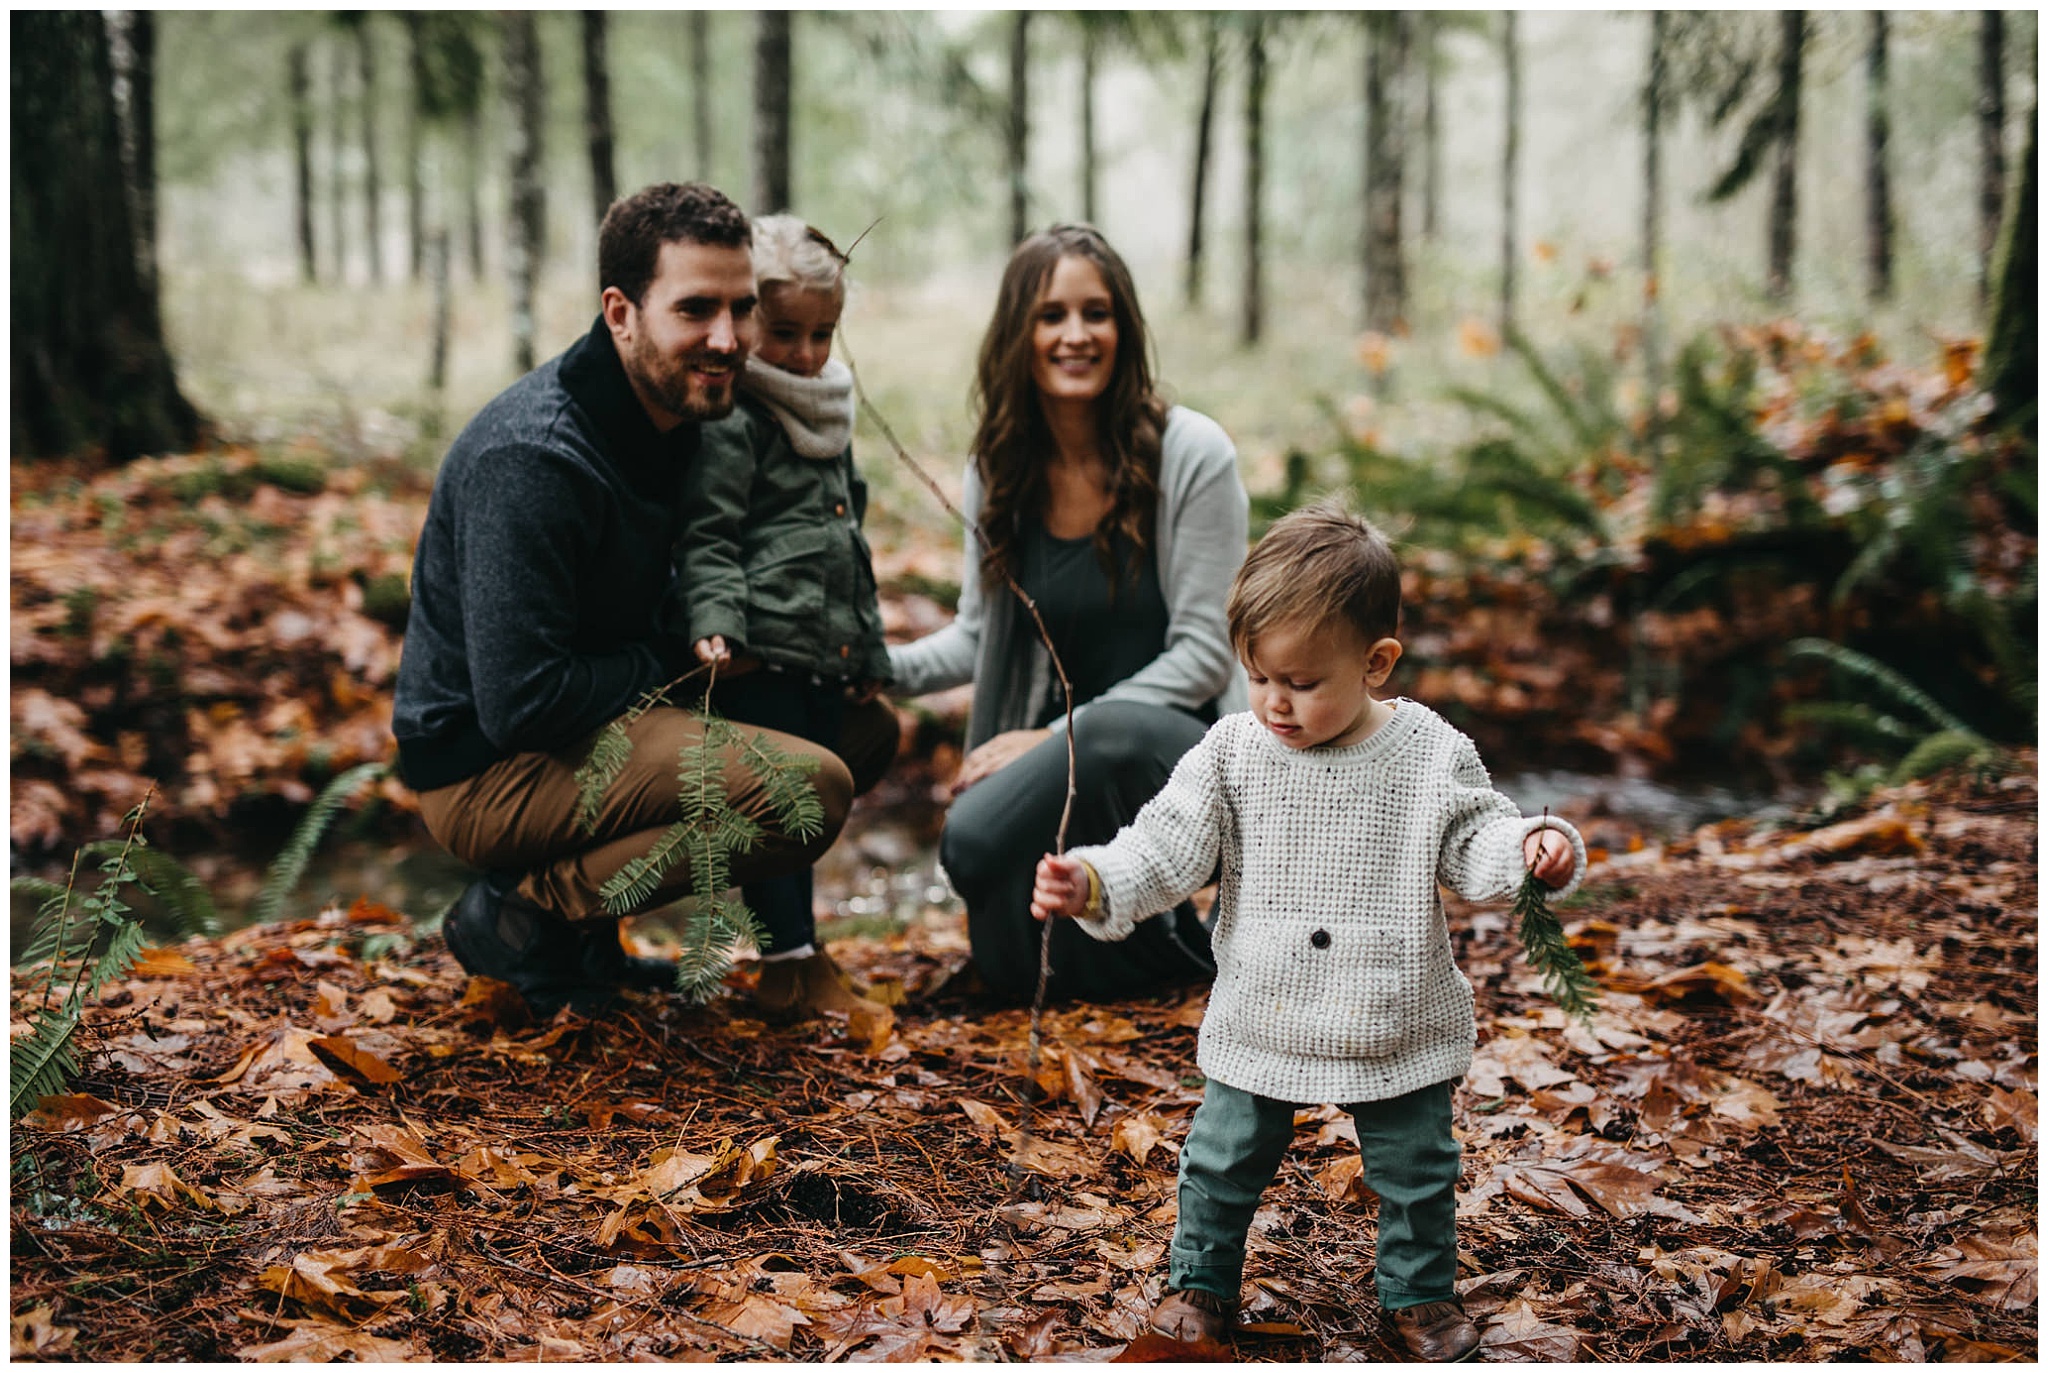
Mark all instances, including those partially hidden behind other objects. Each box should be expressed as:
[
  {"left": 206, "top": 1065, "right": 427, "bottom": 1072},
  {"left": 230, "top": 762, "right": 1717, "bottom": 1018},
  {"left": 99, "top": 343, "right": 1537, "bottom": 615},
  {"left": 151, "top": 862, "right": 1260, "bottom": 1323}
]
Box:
[{"left": 575, "top": 682, "right": 825, "bottom": 1002}]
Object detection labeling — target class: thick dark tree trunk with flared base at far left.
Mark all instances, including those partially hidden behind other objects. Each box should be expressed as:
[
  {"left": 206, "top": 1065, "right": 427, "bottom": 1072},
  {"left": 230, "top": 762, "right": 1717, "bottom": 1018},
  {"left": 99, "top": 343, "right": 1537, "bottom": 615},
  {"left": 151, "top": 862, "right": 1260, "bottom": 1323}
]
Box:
[{"left": 8, "top": 10, "right": 199, "bottom": 461}]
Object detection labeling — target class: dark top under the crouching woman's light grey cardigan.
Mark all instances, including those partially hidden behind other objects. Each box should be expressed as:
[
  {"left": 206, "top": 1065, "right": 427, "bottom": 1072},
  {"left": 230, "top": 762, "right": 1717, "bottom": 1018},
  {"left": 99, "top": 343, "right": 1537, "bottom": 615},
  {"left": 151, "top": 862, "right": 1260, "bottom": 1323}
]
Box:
[{"left": 1018, "top": 518, "right": 1167, "bottom": 727}]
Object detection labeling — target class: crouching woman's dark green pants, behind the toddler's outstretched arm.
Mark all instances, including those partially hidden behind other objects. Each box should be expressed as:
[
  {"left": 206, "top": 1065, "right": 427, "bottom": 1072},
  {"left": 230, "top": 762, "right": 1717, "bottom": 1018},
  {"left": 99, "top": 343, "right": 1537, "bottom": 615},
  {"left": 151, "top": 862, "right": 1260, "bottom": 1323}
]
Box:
[{"left": 940, "top": 701, "right": 1217, "bottom": 1000}]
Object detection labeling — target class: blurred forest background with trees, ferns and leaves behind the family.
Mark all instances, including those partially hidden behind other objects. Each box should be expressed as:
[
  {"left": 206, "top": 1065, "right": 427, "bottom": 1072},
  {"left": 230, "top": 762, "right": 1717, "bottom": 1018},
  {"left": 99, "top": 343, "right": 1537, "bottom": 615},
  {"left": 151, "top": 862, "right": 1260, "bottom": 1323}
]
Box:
[{"left": 10, "top": 10, "right": 2038, "bottom": 913}]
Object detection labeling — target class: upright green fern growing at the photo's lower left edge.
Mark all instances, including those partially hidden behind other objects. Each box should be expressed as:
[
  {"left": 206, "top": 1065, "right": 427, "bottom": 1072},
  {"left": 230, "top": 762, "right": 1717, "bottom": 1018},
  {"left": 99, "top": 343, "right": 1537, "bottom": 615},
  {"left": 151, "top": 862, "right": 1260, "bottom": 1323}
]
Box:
[{"left": 8, "top": 793, "right": 154, "bottom": 1119}]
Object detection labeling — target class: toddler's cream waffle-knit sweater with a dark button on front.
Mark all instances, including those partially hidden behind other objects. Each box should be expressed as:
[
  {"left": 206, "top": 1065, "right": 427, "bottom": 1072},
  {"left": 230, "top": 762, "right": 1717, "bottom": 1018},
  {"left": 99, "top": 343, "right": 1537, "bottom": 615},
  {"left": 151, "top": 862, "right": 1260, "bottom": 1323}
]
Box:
[{"left": 1069, "top": 699, "right": 1585, "bottom": 1105}]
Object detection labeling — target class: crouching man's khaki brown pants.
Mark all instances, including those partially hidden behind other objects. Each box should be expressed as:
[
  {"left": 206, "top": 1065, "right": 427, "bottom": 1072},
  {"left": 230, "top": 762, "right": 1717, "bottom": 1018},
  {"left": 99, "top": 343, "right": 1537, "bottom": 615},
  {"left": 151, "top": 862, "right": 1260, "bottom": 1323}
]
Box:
[{"left": 420, "top": 699, "right": 897, "bottom": 920}]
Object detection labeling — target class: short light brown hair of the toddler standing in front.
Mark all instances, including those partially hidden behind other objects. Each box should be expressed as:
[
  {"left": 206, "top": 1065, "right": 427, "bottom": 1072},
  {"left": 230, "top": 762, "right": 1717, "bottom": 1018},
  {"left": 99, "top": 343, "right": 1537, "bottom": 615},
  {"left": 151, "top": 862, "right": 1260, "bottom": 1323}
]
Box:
[{"left": 1225, "top": 500, "right": 1401, "bottom": 658}]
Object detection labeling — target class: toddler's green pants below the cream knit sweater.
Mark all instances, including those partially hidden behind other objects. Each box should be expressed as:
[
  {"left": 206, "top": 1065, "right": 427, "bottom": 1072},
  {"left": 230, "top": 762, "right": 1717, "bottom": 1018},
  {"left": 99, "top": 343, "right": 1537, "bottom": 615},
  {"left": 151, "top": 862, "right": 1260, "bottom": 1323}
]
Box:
[{"left": 1167, "top": 1078, "right": 1462, "bottom": 1312}]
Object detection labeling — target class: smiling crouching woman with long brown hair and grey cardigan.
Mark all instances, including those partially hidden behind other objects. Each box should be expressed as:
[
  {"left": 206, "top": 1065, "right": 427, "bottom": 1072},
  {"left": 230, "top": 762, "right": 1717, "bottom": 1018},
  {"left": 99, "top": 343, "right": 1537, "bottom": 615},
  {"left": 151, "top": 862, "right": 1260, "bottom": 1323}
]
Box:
[{"left": 889, "top": 225, "right": 1247, "bottom": 1000}]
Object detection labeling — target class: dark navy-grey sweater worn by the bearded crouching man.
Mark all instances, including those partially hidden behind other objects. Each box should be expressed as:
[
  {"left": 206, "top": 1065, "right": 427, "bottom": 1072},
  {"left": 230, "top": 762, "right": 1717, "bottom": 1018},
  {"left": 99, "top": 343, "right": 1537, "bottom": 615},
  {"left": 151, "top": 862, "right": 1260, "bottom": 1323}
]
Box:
[{"left": 391, "top": 318, "right": 696, "bottom": 791}]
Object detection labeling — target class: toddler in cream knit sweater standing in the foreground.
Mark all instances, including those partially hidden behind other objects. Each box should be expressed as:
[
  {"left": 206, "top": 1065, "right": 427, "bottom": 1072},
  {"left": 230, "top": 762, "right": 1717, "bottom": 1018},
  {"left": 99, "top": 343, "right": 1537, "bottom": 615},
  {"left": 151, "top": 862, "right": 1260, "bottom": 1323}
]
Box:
[{"left": 1032, "top": 506, "right": 1585, "bottom": 1361}]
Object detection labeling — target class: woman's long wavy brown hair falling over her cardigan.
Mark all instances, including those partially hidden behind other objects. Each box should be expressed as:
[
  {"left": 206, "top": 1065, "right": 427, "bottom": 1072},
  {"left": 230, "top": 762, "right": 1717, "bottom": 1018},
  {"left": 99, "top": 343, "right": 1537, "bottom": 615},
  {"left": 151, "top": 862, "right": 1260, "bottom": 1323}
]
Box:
[{"left": 975, "top": 223, "right": 1165, "bottom": 590}]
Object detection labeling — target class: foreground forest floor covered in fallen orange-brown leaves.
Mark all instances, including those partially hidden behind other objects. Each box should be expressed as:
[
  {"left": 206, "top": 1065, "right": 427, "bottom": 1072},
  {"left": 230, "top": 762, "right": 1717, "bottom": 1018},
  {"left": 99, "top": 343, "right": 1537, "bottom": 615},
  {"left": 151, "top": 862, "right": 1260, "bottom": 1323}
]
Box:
[{"left": 10, "top": 752, "right": 2038, "bottom": 1363}]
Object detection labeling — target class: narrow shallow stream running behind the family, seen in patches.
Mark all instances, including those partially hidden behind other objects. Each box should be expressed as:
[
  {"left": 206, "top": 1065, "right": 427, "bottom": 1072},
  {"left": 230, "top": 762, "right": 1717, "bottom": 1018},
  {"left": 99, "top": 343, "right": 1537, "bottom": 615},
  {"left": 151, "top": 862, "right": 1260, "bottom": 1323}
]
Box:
[{"left": 10, "top": 773, "right": 1819, "bottom": 951}]
